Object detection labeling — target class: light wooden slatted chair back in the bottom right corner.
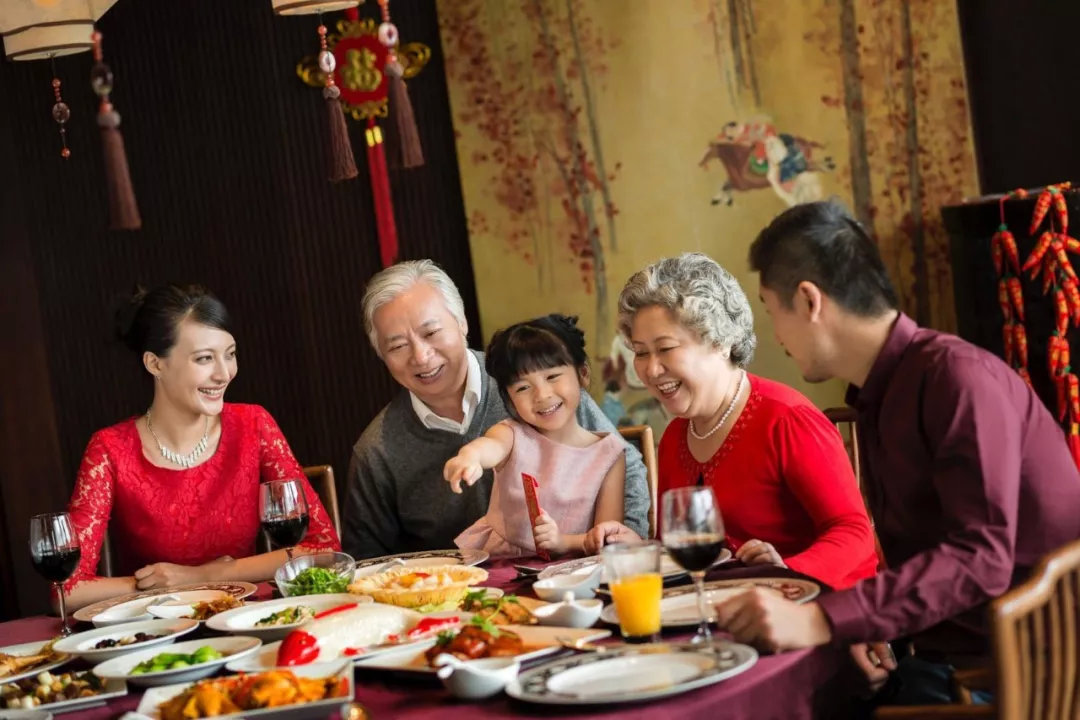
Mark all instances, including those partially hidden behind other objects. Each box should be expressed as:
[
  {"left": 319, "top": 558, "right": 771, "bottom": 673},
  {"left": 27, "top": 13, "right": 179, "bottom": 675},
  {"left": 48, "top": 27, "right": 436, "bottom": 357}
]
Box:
[{"left": 990, "top": 540, "right": 1080, "bottom": 720}]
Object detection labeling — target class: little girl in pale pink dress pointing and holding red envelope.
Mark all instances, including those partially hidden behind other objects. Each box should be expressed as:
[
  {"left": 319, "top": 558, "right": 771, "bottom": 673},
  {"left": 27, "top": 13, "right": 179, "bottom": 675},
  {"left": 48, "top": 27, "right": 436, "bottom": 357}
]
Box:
[{"left": 443, "top": 314, "right": 626, "bottom": 556}]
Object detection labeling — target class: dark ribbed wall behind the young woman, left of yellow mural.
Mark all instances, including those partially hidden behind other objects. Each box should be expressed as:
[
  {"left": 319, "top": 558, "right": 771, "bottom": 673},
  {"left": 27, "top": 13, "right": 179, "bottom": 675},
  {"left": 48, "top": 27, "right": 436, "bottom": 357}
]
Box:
[{"left": 0, "top": 0, "right": 480, "bottom": 610}]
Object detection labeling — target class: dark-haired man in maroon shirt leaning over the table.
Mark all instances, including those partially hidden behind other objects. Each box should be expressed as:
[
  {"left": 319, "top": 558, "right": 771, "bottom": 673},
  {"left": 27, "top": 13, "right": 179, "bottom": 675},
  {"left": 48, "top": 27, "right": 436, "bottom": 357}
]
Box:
[{"left": 717, "top": 202, "right": 1080, "bottom": 703}]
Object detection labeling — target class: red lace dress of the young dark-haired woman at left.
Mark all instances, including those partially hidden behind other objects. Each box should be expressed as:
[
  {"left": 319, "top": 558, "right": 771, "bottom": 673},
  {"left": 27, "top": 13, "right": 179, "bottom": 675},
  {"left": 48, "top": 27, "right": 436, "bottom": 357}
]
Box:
[{"left": 67, "top": 403, "right": 341, "bottom": 588}]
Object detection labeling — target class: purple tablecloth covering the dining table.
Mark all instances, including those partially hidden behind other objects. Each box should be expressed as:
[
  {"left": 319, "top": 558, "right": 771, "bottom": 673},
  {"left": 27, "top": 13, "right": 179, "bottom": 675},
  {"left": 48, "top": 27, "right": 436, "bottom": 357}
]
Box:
[{"left": 0, "top": 561, "right": 850, "bottom": 720}]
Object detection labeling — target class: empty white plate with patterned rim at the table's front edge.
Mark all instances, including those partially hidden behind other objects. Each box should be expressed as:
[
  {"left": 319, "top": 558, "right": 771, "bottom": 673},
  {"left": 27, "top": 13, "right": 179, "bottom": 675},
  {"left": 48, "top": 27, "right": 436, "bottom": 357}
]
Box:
[{"left": 507, "top": 642, "right": 757, "bottom": 705}]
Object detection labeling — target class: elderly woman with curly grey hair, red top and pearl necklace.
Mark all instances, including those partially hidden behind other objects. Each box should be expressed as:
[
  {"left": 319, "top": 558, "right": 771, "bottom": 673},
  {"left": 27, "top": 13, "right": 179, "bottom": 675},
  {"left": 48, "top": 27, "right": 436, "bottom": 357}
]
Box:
[{"left": 586, "top": 254, "right": 877, "bottom": 588}]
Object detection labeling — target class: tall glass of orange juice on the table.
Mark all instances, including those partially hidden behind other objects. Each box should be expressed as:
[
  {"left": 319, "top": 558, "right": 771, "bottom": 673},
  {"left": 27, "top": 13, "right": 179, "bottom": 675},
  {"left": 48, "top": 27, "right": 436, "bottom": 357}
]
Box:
[{"left": 602, "top": 541, "right": 663, "bottom": 642}]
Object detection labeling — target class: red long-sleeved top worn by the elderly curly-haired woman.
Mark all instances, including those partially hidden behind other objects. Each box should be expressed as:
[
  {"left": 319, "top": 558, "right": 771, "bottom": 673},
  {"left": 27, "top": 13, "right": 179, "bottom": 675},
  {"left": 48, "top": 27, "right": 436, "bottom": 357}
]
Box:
[{"left": 659, "top": 373, "right": 877, "bottom": 589}]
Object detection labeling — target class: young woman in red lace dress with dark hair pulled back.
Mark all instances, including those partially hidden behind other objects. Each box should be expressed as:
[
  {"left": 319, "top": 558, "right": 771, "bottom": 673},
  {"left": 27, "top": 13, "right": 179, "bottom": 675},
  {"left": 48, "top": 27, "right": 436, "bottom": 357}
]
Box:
[{"left": 67, "top": 285, "right": 340, "bottom": 608}]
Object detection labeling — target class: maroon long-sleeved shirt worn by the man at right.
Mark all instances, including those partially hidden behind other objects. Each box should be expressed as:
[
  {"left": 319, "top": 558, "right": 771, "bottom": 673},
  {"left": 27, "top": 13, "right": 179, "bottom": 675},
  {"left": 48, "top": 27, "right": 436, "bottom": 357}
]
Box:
[{"left": 820, "top": 314, "right": 1080, "bottom": 654}]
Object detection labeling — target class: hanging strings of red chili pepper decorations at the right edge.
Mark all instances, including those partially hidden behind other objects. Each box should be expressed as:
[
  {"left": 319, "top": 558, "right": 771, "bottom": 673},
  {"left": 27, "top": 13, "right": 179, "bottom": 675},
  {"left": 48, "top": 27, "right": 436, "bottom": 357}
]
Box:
[{"left": 990, "top": 182, "right": 1080, "bottom": 465}]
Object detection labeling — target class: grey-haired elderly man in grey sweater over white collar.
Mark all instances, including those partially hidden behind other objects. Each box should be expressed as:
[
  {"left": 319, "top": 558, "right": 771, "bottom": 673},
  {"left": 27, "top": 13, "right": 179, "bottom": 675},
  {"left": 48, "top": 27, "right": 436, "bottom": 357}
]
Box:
[{"left": 341, "top": 260, "right": 649, "bottom": 558}]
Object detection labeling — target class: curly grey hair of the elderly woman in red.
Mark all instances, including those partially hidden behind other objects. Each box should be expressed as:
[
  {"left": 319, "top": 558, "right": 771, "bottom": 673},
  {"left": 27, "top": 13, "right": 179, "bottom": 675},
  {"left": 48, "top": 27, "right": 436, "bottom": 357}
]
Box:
[{"left": 619, "top": 253, "right": 757, "bottom": 367}]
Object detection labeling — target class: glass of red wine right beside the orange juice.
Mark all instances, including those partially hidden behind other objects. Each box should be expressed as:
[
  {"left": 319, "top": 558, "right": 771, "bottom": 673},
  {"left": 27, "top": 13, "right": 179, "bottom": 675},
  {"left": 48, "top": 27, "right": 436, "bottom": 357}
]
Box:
[{"left": 661, "top": 486, "right": 724, "bottom": 642}]
